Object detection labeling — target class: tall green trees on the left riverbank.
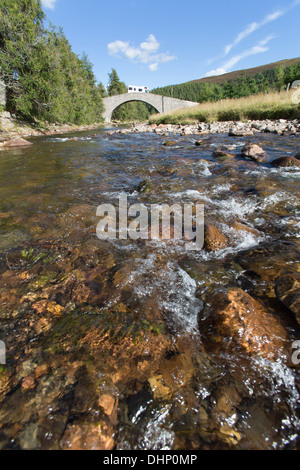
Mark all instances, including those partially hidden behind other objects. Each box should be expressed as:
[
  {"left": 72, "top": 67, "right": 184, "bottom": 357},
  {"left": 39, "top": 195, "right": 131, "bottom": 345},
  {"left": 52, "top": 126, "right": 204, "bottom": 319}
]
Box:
[{"left": 0, "top": 0, "right": 103, "bottom": 124}]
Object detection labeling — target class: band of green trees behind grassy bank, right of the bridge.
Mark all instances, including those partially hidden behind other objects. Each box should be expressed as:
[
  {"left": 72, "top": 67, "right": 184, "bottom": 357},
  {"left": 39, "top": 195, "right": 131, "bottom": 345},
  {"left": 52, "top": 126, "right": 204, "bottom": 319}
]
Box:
[{"left": 152, "top": 62, "right": 300, "bottom": 103}]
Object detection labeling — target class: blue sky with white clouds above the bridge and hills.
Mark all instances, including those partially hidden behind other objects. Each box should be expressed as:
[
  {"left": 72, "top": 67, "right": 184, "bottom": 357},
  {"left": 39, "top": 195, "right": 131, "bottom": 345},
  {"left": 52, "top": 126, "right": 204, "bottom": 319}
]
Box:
[{"left": 42, "top": 0, "right": 300, "bottom": 89}]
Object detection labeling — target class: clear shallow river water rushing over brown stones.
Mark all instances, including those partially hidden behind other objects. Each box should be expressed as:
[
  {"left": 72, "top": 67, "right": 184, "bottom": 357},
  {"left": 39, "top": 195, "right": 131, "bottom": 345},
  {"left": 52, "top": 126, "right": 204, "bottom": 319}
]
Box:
[{"left": 0, "top": 126, "right": 300, "bottom": 450}]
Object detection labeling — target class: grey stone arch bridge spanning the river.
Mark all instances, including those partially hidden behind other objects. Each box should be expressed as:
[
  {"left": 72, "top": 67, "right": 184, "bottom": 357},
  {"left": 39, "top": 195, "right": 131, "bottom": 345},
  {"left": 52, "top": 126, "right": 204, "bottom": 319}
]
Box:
[{"left": 103, "top": 93, "right": 199, "bottom": 122}]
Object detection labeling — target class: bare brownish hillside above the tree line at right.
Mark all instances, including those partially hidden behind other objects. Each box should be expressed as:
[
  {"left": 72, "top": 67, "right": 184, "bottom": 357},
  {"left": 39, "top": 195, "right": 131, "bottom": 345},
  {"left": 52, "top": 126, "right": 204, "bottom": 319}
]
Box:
[{"left": 186, "top": 57, "right": 300, "bottom": 84}]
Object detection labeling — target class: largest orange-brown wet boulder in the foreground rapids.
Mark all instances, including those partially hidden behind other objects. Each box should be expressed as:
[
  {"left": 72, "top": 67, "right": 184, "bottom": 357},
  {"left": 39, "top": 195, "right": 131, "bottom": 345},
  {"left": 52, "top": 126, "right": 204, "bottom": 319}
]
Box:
[{"left": 199, "top": 288, "right": 287, "bottom": 360}]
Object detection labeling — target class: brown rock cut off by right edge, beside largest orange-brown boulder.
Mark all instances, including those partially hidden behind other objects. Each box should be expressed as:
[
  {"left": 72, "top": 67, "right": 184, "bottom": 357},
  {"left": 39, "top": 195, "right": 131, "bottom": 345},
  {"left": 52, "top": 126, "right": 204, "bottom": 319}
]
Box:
[{"left": 275, "top": 273, "right": 300, "bottom": 324}]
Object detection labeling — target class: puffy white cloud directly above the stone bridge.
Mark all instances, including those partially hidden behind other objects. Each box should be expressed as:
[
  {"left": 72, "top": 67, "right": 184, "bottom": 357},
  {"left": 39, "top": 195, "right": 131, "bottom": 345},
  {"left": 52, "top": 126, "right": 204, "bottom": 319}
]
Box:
[{"left": 107, "top": 34, "right": 176, "bottom": 72}]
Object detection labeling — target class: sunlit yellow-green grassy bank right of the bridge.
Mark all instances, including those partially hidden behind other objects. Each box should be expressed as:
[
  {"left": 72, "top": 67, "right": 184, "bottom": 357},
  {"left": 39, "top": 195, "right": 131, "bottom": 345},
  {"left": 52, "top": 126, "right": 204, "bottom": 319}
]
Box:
[{"left": 149, "top": 91, "right": 300, "bottom": 124}]
